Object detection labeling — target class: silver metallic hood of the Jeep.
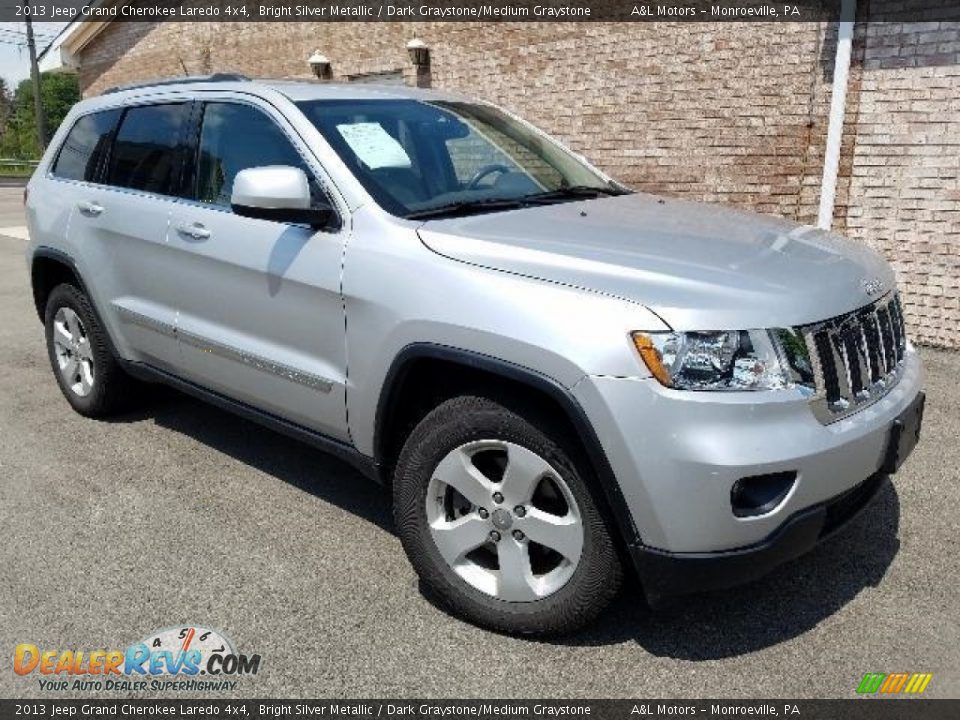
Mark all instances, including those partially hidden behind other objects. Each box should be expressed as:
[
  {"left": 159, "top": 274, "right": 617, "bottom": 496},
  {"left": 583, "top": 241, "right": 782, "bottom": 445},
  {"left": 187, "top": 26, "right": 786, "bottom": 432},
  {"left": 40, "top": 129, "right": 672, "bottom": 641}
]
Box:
[{"left": 418, "top": 193, "right": 895, "bottom": 330}]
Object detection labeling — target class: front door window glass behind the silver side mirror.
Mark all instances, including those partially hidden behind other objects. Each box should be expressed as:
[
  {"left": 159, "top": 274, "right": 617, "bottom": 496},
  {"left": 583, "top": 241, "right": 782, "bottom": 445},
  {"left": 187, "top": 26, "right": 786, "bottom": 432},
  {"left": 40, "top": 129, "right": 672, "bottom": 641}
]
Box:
[{"left": 196, "top": 103, "right": 324, "bottom": 207}]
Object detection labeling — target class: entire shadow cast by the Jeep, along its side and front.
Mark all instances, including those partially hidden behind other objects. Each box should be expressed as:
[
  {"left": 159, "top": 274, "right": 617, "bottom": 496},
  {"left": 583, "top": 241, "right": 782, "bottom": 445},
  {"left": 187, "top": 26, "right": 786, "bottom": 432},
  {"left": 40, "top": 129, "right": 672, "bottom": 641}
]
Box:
[{"left": 112, "top": 388, "right": 900, "bottom": 660}]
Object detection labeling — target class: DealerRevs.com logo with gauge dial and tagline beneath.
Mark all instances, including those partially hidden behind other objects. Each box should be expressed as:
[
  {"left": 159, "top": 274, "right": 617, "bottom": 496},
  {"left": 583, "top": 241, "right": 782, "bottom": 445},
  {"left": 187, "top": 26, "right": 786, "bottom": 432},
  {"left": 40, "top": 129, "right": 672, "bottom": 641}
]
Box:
[{"left": 13, "top": 625, "right": 260, "bottom": 690}]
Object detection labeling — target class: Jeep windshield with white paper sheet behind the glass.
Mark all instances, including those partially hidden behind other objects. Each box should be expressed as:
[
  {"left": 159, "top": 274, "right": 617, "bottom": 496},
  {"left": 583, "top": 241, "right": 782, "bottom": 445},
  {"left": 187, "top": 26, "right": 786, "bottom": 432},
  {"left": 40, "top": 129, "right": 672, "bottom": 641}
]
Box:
[{"left": 298, "top": 100, "right": 627, "bottom": 218}]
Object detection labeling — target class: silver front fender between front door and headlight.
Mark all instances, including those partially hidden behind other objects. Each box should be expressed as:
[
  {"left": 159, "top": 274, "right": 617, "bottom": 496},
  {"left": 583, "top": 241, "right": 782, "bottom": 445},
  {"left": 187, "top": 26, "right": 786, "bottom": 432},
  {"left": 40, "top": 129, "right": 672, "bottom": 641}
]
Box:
[{"left": 342, "top": 208, "right": 669, "bottom": 455}]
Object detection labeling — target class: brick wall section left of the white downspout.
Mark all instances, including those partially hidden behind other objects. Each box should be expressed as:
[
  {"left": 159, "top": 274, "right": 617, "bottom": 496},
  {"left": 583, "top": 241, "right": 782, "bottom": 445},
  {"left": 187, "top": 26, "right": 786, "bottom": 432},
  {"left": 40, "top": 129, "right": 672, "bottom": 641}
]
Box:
[{"left": 80, "top": 23, "right": 830, "bottom": 222}]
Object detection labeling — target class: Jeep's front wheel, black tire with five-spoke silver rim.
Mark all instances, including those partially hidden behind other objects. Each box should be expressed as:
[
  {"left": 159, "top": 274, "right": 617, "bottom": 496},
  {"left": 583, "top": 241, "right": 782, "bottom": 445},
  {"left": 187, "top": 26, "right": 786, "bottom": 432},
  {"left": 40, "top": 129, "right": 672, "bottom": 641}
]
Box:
[{"left": 393, "top": 396, "right": 622, "bottom": 635}]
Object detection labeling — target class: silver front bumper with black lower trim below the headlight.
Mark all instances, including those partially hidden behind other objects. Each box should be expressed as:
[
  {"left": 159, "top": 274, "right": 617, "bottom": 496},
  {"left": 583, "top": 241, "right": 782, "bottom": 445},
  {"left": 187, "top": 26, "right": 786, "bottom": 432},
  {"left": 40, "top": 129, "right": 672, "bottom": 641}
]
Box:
[{"left": 574, "top": 349, "right": 923, "bottom": 594}]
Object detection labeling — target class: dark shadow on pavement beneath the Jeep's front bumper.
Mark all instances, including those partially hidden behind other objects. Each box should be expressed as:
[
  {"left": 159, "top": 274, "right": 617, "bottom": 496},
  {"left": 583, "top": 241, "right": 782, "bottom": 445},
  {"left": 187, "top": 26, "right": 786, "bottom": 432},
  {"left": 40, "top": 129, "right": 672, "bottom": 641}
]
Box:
[{"left": 561, "top": 481, "right": 900, "bottom": 660}]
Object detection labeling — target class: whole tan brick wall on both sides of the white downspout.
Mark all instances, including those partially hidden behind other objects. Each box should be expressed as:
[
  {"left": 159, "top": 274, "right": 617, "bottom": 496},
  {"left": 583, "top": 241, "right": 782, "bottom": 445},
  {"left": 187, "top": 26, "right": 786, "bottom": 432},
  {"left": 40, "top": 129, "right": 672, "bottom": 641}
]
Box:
[{"left": 80, "top": 23, "right": 960, "bottom": 347}]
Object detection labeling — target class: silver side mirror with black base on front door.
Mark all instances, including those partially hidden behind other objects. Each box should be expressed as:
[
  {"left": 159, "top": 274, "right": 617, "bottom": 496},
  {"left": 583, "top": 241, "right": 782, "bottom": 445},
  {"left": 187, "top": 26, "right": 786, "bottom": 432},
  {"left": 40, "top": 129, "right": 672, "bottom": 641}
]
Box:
[{"left": 230, "top": 165, "right": 335, "bottom": 228}]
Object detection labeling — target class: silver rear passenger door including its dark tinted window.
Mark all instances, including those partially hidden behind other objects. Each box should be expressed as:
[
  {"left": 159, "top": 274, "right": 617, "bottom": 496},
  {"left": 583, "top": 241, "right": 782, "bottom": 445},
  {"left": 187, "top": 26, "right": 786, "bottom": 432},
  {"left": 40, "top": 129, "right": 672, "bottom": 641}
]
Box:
[{"left": 70, "top": 102, "right": 191, "bottom": 369}]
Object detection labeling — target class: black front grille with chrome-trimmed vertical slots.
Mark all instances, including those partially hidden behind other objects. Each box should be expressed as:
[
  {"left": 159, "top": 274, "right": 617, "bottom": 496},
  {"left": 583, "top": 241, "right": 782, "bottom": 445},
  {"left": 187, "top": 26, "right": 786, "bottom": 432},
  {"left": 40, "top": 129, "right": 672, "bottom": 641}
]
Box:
[{"left": 798, "top": 293, "right": 907, "bottom": 424}]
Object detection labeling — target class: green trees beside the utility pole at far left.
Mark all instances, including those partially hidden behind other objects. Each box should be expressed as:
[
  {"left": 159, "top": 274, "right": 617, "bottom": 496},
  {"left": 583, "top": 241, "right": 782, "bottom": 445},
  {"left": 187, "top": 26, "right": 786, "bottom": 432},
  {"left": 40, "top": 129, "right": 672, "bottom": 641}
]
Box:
[{"left": 0, "top": 73, "right": 80, "bottom": 160}]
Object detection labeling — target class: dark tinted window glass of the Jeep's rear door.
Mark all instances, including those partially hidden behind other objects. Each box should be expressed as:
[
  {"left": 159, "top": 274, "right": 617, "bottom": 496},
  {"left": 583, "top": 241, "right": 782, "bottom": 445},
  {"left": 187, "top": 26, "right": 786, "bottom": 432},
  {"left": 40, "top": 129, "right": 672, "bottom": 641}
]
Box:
[{"left": 107, "top": 103, "right": 189, "bottom": 195}]
